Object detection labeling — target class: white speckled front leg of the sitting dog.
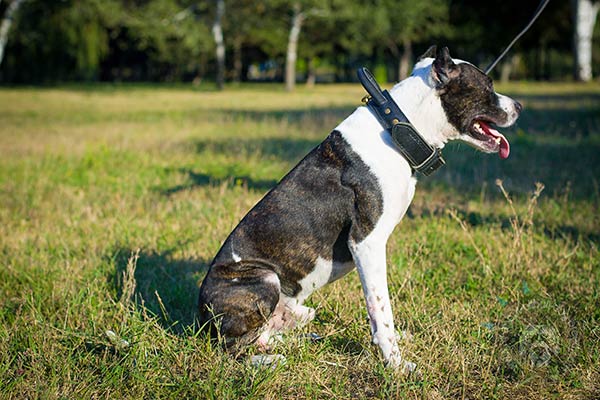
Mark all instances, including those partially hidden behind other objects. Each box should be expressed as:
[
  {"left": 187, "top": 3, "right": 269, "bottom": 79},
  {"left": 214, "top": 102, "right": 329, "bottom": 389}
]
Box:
[{"left": 350, "top": 240, "right": 415, "bottom": 372}]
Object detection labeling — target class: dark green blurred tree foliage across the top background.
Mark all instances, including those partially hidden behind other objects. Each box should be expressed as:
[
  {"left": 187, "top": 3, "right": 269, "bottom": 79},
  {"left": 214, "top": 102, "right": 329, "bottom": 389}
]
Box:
[{"left": 0, "top": 0, "right": 600, "bottom": 83}]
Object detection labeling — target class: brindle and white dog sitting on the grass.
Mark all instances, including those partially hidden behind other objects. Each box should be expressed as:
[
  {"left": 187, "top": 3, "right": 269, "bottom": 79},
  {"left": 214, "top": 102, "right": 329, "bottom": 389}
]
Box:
[{"left": 199, "top": 47, "right": 521, "bottom": 371}]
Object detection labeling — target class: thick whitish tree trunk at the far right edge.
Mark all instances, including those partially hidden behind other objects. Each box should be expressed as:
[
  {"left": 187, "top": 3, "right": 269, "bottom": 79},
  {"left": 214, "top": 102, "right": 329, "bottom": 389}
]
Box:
[{"left": 571, "top": 0, "right": 600, "bottom": 82}]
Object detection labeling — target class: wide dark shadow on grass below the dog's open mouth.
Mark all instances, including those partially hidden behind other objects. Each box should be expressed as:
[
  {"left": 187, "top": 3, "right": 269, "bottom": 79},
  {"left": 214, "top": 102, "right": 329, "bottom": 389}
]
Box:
[{"left": 420, "top": 135, "right": 600, "bottom": 199}]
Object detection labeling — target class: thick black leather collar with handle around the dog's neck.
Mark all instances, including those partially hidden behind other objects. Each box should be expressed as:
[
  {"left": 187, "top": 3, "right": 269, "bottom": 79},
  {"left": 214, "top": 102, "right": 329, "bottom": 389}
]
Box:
[{"left": 357, "top": 67, "right": 446, "bottom": 176}]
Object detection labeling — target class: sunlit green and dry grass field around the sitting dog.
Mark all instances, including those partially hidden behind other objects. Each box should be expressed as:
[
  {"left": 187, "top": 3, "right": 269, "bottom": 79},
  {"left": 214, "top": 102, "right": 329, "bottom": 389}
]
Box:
[{"left": 0, "top": 83, "right": 600, "bottom": 399}]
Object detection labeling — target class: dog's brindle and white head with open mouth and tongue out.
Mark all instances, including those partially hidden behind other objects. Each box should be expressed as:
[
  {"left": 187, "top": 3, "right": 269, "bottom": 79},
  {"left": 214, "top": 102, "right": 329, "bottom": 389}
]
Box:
[{"left": 415, "top": 46, "right": 522, "bottom": 158}]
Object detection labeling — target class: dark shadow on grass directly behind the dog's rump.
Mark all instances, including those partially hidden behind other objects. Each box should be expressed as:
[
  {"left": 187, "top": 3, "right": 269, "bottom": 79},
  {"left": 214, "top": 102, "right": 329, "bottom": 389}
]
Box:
[{"left": 113, "top": 249, "right": 210, "bottom": 333}]
